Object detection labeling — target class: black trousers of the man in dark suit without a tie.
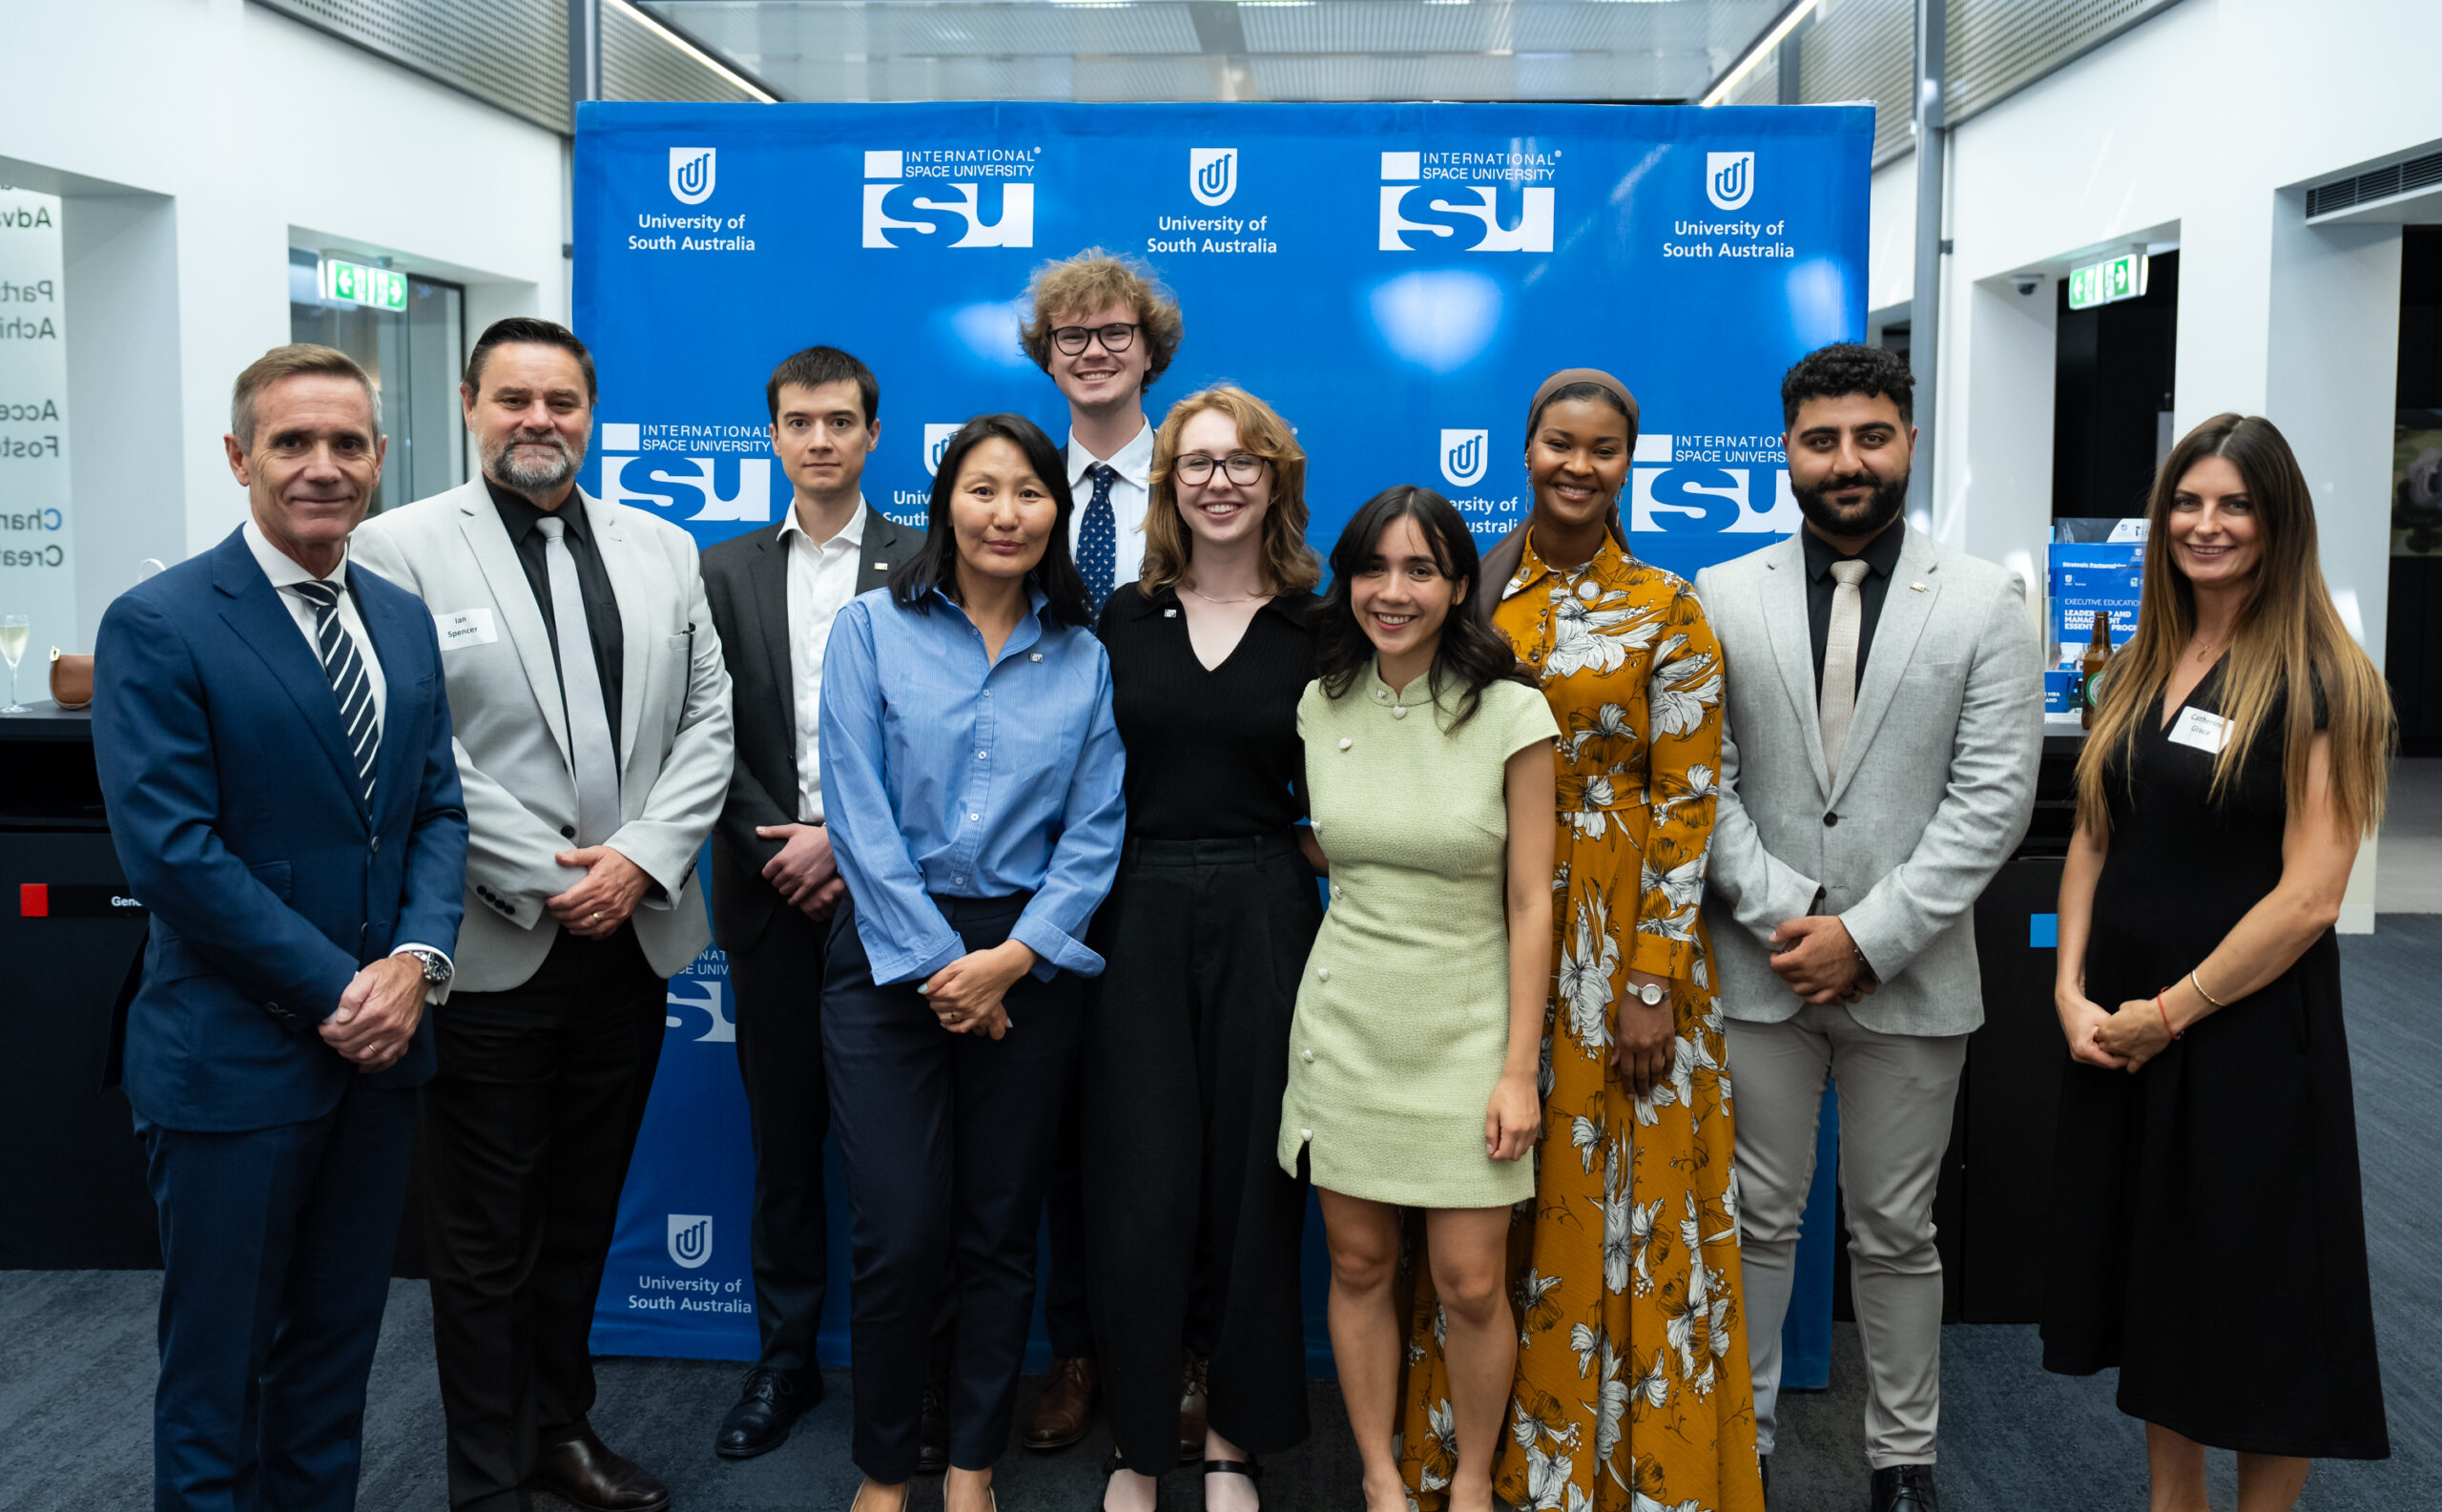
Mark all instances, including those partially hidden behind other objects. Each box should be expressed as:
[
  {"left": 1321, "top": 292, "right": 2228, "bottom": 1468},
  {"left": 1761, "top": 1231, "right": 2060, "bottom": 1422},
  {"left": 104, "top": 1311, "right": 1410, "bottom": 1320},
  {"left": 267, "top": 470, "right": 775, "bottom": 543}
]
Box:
[{"left": 730, "top": 906, "right": 830, "bottom": 1373}]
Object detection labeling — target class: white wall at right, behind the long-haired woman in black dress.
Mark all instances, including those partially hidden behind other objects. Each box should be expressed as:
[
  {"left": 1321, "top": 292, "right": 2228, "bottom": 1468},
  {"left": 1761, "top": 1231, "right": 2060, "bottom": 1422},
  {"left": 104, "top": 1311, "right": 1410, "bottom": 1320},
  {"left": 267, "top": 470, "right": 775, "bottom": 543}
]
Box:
[{"left": 1868, "top": 0, "right": 2442, "bottom": 928}]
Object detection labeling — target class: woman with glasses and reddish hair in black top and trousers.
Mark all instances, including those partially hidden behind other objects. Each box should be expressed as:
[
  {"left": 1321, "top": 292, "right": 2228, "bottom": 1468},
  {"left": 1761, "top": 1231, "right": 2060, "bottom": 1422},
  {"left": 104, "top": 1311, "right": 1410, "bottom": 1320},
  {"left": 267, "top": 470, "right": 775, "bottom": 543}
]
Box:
[{"left": 1080, "top": 388, "right": 1321, "bottom": 1512}]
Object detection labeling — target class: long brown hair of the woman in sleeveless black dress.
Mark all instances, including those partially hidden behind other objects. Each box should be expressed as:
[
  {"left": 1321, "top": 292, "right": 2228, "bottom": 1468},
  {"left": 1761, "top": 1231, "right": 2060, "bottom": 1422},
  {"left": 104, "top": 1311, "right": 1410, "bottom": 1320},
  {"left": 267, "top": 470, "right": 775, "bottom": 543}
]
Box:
[{"left": 2079, "top": 415, "right": 2395, "bottom": 836}]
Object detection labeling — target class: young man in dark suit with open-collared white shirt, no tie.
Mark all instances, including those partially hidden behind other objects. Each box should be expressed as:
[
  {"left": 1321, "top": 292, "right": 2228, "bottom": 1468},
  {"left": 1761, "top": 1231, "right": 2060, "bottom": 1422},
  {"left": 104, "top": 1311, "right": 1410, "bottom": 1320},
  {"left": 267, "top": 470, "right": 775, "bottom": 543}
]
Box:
[{"left": 703, "top": 347, "right": 923, "bottom": 1459}]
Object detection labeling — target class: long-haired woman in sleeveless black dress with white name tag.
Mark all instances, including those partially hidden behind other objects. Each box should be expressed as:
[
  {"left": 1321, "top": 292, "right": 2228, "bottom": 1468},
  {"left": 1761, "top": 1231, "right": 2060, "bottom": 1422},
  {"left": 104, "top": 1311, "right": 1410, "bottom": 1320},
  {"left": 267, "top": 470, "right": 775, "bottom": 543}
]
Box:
[{"left": 2044, "top": 415, "right": 2393, "bottom": 1512}]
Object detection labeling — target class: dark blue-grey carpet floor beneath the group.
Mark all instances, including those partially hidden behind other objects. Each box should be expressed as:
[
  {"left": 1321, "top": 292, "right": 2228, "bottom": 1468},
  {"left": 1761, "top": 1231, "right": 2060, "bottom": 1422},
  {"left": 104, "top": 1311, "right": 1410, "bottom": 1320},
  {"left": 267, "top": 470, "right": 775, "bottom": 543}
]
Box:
[{"left": 0, "top": 914, "right": 2442, "bottom": 1512}]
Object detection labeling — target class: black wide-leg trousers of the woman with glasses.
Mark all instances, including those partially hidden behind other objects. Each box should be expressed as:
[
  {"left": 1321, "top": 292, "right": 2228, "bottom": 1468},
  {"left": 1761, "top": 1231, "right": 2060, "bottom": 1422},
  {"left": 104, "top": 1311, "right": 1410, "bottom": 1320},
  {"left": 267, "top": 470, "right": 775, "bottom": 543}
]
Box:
[{"left": 1080, "top": 836, "right": 1321, "bottom": 1473}]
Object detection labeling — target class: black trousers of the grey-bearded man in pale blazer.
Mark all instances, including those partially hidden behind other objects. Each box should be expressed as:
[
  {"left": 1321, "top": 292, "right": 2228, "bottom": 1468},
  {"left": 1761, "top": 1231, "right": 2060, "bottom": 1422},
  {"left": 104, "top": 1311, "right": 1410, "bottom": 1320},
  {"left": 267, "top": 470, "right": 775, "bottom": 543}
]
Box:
[{"left": 423, "top": 925, "right": 669, "bottom": 1512}]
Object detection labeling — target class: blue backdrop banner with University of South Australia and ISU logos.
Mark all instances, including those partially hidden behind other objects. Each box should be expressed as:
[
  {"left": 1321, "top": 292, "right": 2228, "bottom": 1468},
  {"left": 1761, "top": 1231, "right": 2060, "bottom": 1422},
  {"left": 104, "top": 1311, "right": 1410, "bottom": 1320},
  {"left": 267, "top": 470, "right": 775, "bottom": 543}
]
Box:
[{"left": 574, "top": 105, "right": 1873, "bottom": 1358}]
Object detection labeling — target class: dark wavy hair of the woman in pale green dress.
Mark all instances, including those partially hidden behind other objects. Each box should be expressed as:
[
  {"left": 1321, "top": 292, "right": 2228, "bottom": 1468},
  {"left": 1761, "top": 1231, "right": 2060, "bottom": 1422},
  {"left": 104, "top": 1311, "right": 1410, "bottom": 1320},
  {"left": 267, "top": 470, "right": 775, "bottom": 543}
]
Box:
[{"left": 1314, "top": 484, "right": 1536, "bottom": 731}]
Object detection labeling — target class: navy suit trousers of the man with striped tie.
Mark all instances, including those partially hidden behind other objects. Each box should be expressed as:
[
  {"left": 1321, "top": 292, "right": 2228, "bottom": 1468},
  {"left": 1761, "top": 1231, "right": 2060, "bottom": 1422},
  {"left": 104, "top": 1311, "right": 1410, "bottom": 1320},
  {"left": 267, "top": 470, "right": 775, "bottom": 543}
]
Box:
[{"left": 136, "top": 1077, "right": 415, "bottom": 1512}]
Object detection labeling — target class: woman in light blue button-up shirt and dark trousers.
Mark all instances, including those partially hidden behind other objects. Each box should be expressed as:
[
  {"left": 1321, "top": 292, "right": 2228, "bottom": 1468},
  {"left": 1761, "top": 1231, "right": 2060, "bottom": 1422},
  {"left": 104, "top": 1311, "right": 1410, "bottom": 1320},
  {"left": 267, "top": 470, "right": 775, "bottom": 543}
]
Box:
[{"left": 823, "top": 415, "right": 1126, "bottom": 1512}]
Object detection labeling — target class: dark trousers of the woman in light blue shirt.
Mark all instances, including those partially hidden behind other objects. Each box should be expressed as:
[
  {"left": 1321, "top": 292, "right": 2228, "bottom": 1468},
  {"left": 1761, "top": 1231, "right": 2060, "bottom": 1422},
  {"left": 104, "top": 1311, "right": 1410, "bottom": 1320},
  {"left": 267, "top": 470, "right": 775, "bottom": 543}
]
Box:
[{"left": 823, "top": 897, "right": 1085, "bottom": 1485}]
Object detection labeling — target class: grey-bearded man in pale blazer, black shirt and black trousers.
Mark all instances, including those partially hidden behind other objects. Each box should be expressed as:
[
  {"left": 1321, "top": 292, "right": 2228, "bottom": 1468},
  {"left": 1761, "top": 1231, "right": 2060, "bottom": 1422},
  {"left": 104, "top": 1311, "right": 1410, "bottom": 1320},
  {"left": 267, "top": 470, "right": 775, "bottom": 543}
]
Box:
[{"left": 354, "top": 318, "right": 733, "bottom": 1512}]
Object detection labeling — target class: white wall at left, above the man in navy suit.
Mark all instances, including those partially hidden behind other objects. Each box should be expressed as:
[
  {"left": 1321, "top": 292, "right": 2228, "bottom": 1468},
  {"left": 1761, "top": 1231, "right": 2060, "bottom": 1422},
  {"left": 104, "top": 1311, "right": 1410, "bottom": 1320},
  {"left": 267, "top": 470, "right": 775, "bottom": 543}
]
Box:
[{"left": 0, "top": 0, "right": 569, "bottom": 645}]
